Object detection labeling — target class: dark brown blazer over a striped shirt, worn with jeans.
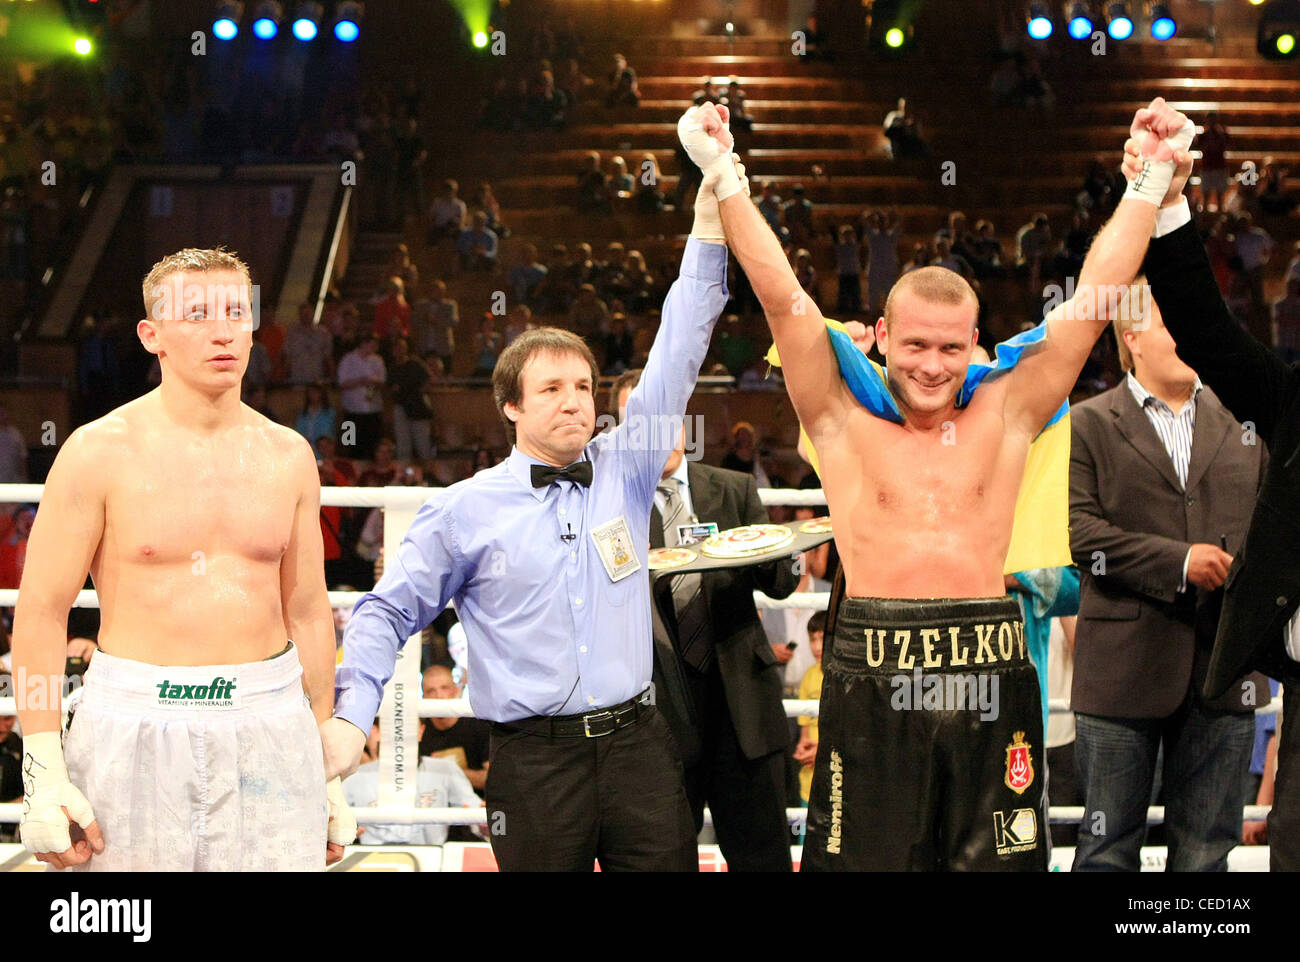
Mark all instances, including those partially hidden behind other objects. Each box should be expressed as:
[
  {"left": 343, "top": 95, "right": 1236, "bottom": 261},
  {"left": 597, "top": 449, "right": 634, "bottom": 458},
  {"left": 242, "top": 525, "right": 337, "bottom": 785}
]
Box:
[{"left": 1070, "top": 382, "right": 1269, "bottom": 718}]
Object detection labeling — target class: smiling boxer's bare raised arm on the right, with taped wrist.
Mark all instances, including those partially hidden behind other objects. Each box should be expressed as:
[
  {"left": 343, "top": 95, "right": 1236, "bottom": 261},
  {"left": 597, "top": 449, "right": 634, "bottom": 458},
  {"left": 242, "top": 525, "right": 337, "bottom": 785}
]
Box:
[{"left": 1006, "top": 98, "right": 1193, "bottom": 437}]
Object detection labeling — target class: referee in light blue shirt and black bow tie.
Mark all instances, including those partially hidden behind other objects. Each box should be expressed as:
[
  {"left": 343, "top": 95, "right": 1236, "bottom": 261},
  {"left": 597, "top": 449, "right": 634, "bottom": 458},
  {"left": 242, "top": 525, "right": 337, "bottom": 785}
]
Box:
[{"left": 322, "top": 114, "right": 744, "bottom": 871}]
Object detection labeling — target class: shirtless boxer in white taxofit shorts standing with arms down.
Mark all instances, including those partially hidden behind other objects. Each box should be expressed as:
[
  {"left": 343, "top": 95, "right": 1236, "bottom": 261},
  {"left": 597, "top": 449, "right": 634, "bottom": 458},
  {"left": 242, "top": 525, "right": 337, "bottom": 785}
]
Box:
[{"left": 13, "top": 250, "right": 355, "bottom": 871}]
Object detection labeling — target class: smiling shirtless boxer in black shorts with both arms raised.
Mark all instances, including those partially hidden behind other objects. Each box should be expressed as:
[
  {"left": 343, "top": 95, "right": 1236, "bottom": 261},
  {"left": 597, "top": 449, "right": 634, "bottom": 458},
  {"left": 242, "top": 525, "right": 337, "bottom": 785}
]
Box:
[{"left": 684, "top": 99, "right": 1192, "bottom": 871}]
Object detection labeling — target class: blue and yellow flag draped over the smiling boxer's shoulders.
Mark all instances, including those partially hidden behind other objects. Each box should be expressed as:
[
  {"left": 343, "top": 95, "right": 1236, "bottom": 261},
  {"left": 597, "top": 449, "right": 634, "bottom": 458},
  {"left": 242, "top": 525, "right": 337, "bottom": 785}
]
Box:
[{"left": 767, "top": 317, "right": 1073, "bottom": 575}]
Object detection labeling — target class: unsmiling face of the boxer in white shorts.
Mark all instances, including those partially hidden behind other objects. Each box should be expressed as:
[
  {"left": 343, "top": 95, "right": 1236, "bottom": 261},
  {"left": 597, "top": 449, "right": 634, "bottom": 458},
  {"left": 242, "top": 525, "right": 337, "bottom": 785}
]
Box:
[{"left": 137, "top": 270, "right": 255, "bottom": 394}]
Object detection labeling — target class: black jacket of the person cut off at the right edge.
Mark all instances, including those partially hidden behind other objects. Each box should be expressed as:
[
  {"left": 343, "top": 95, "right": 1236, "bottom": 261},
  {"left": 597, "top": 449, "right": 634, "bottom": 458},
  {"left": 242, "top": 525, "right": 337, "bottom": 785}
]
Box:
[{"left": 1145, "top": 224, "right": 1300, "bottom": 696}]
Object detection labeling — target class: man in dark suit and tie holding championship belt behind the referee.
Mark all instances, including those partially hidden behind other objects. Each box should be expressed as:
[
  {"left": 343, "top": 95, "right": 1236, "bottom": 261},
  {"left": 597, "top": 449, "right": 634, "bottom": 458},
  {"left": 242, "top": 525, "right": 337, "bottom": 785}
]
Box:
[{"left": 610, "top": 371, "right": 798, "bottom": 871}]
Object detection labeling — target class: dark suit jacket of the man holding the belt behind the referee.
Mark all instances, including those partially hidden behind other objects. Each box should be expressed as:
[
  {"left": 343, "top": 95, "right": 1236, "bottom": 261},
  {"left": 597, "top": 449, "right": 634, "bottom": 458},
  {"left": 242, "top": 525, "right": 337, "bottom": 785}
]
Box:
[{"left": 650, "top": 462, "right": 800, "bottom": 766}]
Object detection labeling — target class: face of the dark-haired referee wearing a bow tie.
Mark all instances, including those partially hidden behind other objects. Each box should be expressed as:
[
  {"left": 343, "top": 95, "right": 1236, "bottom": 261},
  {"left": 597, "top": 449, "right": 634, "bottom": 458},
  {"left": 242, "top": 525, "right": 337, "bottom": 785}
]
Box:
[{"left": 504, "top": 351, "right": 595, "bottom": 465}]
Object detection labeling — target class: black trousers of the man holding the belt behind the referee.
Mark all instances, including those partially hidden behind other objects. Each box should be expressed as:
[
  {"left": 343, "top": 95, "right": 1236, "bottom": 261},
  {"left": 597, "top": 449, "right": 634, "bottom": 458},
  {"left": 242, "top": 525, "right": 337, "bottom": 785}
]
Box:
[{"left": 685, "top": 660, "right": 793, "bottom": 872}]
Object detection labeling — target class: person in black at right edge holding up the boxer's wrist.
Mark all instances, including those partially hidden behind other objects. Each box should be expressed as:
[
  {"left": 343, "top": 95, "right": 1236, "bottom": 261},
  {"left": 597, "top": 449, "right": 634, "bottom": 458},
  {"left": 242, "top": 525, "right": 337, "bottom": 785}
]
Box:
[{"left": 1125, "top": 142, "right": 1300, "bottom": 871}]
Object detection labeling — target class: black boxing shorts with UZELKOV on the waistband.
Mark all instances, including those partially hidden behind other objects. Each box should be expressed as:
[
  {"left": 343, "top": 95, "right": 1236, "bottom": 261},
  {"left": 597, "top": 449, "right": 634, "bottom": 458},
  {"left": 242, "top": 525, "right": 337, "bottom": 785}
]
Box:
[{"left": 802, "top": 597, "right": 1048, "bottom": 871}]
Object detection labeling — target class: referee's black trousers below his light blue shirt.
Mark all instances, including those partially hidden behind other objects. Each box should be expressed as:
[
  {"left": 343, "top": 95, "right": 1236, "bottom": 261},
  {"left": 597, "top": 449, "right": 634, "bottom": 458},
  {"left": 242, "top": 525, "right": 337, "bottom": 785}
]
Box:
[{"left": 486, "top": 707, "right": 699, "bottom": 872}]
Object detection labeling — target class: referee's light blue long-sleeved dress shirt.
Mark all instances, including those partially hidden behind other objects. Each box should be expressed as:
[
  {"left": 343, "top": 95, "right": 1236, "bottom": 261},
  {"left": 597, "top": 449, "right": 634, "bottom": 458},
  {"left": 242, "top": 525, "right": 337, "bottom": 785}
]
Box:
[{"left": 334, "top": 238, "right": 727, "bottom": 732}]
